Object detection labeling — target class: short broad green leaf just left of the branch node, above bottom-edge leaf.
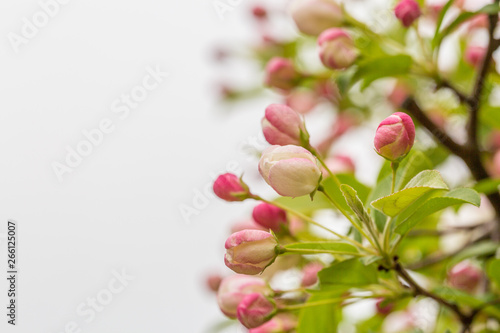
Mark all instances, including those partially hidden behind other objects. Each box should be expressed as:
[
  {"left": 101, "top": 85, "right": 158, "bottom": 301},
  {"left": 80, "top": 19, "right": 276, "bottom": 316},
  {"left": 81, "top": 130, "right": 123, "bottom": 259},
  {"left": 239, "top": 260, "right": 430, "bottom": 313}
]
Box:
[{"left": 318, "top": 258, "right": 378, "bottom": 288}]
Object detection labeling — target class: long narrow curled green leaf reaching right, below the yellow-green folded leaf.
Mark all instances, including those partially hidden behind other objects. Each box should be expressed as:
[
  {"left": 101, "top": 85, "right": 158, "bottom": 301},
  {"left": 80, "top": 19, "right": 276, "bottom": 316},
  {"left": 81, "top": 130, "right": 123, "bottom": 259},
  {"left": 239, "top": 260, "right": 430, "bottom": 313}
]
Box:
[{"left": 395, "top": 188, "right": 481, "bottom": 235}]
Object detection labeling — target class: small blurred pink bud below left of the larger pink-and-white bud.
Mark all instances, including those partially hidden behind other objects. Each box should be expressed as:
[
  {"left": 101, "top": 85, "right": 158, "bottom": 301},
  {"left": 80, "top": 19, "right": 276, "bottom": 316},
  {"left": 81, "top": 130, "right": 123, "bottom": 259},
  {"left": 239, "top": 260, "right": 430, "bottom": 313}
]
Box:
[{"left": 265, "top": 57, "right": 300, "bottom": 91}]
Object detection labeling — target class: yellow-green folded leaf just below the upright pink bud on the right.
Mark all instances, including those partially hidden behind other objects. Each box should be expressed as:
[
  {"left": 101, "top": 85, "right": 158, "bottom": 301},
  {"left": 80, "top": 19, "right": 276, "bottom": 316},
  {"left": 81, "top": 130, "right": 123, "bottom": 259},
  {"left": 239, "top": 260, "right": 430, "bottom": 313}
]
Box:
[{"left": 371, "top": 170, "right": 448, "bottom": 217}]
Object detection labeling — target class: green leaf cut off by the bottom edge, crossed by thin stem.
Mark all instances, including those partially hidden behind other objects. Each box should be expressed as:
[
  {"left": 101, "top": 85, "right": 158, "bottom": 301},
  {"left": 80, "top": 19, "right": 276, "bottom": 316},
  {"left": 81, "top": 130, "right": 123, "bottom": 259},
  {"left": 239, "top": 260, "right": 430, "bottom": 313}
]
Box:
[{"left": 297, "top": 293, "right": 342, "bottom": 333}]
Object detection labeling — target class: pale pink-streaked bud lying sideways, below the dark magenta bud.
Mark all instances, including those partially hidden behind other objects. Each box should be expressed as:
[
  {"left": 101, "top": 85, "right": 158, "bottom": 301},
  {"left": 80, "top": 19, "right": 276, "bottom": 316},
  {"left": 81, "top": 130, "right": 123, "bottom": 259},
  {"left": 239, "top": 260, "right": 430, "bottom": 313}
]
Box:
[{"left": 224, "top": 230, "right": 278, "bottom": 275}]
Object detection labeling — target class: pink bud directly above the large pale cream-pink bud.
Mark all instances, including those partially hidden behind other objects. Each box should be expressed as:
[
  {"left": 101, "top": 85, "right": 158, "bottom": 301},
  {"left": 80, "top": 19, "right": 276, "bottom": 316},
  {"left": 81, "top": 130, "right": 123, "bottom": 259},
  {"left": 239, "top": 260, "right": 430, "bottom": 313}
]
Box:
[{"left": 261, "top": 104, "right": 305, "bottom": 146}]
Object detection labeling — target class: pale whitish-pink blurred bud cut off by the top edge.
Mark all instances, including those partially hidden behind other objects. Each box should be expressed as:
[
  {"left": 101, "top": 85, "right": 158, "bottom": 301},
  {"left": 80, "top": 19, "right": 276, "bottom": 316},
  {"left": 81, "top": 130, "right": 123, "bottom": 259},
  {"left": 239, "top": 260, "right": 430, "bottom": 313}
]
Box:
[{"left": 290, "top": 0, "right": 343, "bottom": 36}]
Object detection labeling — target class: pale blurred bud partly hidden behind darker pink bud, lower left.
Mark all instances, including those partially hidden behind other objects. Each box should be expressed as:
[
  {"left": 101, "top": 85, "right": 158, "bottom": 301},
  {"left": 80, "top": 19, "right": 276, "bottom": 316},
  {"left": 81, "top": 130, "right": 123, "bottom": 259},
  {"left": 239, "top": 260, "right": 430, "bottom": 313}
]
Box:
[{"left": 217, "top": 275, "right": 273, "bottom": 318}]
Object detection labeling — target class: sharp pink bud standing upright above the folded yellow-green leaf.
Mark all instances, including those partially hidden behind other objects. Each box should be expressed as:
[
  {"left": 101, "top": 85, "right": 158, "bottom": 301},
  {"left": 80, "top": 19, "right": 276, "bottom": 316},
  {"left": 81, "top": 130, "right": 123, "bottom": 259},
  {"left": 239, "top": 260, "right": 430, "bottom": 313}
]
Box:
[{"left": 375, "top": 112, "right": 415, "bottom": 162}]
